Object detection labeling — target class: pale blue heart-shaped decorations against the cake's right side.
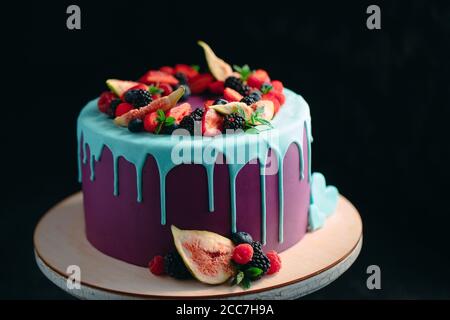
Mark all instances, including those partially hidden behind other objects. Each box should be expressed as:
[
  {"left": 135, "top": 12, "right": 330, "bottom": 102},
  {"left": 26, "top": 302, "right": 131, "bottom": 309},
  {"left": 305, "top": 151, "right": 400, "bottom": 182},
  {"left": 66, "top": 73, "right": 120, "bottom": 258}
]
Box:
[{"left": 308, "top": 172, "right": 339, "bottom": 230}]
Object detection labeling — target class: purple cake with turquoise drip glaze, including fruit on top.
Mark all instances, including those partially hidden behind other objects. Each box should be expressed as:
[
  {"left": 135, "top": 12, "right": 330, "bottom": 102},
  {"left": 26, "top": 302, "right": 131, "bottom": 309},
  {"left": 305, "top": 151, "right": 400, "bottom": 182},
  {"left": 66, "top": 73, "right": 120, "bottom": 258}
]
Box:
[{"left": 77, "top": 42, "right": 337, "bottom": 284}]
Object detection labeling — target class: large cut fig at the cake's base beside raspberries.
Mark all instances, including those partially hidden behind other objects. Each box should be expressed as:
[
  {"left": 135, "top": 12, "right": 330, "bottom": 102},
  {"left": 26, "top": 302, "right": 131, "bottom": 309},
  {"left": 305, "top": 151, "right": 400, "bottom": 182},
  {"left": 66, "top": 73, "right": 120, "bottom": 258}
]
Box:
[{"left": 171, "top": 226, "right": 234, "bottom": 284}]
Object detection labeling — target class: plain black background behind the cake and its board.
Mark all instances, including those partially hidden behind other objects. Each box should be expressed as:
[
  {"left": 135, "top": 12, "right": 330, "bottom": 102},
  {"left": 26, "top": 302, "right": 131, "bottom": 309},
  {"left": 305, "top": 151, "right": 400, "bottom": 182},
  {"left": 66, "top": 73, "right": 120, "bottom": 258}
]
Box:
[{"left": 0, "top": 1, "right": 450, "bottom": 299}]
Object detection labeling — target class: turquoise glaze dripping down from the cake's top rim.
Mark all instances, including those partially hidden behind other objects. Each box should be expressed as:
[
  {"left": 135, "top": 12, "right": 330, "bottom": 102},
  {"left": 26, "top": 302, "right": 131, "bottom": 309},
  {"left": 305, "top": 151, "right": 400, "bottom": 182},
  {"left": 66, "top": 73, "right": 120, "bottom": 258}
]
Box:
[{"left": 77, "top": 89, "right": 312, "bottom": 243}]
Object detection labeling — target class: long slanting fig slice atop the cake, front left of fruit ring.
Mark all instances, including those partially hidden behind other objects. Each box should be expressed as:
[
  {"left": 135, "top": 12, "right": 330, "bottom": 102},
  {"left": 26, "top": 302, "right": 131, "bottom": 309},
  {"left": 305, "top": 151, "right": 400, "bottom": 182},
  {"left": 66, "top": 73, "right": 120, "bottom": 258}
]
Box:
[{"left": 114, "top": 86, "right": 184, "bottom": 127}]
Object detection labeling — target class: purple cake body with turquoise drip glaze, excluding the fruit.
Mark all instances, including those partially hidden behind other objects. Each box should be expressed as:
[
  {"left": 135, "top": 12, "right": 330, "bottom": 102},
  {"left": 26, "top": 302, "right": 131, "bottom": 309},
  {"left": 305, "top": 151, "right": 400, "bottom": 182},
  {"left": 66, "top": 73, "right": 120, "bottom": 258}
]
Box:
[{"left": 77, "top": 89, "right": 311, "bottom": 266}]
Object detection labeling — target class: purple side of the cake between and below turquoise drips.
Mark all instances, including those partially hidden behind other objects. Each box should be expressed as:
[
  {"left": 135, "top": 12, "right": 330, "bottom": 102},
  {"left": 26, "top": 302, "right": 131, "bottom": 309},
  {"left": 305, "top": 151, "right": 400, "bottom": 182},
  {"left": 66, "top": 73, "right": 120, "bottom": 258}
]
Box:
[{"left": 80, "top": 133, "right": 310, "bottom": 266}]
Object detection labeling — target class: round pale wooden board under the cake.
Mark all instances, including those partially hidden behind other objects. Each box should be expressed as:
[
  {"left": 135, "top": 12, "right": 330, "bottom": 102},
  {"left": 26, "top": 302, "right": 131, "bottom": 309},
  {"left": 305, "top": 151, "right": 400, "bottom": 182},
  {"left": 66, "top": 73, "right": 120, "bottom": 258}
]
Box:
[{"left": 34, "top": 193, "right": 362, "bottom": 299}]
